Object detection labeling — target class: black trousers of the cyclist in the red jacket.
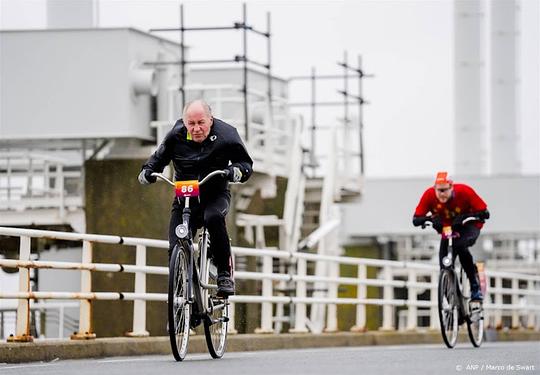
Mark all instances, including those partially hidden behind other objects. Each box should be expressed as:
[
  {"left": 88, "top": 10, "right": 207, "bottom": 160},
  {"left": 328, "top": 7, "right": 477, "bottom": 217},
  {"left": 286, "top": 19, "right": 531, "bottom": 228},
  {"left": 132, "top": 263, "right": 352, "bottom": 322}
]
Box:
[{"left": 439, "top": 223, "right": 480, "bottom": 288}]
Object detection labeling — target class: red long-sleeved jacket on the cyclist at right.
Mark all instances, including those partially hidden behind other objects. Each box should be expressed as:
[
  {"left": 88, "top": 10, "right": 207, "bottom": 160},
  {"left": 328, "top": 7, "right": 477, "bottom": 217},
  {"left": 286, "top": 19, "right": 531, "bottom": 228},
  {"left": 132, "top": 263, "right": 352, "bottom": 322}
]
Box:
[{"left": 414, "top": 184, "right": 487, "bottom": 228}]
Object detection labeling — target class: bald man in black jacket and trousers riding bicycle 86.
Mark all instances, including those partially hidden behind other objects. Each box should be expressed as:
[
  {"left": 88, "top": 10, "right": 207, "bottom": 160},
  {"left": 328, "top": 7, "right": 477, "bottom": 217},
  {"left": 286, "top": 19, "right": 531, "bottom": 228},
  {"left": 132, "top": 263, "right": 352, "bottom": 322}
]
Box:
[{"left": 138, "top": 100, "right": 253, "bottom": 297}]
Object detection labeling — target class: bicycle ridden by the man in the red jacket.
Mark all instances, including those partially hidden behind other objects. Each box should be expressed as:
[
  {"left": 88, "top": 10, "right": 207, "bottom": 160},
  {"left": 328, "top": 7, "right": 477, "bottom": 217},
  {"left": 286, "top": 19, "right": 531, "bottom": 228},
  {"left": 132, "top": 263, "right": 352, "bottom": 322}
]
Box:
[{"left": 422, "top": 216, "right": 484, "bottom": 348}]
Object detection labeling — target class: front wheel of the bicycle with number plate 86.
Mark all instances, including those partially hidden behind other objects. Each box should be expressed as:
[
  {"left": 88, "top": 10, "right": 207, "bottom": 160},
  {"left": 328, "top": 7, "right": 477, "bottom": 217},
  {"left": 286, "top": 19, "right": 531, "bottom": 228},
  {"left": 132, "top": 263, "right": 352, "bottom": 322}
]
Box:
[{"left": 167, "top": 245, "right": 190, "bottom": 361}]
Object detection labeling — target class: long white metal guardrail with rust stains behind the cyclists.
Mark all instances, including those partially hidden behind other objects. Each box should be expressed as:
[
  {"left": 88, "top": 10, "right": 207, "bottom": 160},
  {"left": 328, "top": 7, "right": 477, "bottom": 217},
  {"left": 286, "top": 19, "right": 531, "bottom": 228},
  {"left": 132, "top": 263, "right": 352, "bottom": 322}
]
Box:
[{"left": 0, "top": 227, "right": 540, "bottom": 341}]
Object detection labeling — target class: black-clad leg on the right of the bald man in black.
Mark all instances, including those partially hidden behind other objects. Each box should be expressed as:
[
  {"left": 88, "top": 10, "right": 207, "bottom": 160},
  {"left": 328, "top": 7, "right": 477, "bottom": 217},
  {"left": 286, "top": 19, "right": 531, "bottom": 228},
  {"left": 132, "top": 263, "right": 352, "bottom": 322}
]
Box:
[{"left": 204, "top": 192, "right": 234, "bottom": 297}]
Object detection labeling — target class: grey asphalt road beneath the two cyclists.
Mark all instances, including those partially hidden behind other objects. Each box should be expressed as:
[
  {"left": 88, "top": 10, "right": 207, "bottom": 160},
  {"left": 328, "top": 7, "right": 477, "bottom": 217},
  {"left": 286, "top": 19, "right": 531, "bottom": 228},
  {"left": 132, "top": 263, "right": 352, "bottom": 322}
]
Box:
[{"left": 0, "top": 341, "right": 540, "bottom": 375}]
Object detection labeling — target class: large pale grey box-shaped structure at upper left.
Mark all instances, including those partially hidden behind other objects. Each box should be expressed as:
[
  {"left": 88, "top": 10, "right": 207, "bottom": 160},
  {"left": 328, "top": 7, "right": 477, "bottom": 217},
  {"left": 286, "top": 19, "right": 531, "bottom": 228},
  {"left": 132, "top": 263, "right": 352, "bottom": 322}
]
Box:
[{"left": 0, "top": 28, "right": 179, "bottom": 141}]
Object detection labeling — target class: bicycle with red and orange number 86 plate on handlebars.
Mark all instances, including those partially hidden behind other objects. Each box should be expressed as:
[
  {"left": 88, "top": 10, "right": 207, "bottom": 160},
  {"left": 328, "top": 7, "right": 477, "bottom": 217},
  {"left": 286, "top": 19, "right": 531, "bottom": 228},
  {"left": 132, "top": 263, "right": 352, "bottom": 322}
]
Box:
[{"left": 152, "top": 170, "right": 229, "bottom": 361}]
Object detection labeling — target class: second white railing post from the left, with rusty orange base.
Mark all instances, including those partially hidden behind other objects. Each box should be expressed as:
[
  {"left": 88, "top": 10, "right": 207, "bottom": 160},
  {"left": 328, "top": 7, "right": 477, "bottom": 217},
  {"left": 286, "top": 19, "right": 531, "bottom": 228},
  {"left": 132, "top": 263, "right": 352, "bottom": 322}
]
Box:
[{"left": 71, "top": 241, "right": 96, "bottom": 340}]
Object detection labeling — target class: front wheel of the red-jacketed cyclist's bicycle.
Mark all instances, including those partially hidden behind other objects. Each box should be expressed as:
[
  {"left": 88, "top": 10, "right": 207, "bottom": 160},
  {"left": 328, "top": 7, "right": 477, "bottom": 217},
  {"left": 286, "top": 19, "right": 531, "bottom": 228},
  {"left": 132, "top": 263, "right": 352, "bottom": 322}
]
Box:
[{"left": 439, "top": 270, "right": 458, "bottom": 348}]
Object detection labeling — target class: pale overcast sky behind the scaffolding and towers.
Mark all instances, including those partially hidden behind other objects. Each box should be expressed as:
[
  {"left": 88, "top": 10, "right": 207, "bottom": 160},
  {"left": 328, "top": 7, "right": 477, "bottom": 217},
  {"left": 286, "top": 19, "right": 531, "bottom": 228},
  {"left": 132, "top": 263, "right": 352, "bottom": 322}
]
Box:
[{"left": 0, "top": 0, "right": 540, "bottom": 176}]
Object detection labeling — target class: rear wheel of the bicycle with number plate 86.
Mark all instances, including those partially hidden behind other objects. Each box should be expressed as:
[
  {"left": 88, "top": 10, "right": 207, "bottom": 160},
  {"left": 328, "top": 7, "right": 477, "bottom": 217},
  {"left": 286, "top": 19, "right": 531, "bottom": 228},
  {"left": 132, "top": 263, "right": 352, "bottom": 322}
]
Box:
[{"left": 203, "top": 259, "right": 229, "bottom": 359}]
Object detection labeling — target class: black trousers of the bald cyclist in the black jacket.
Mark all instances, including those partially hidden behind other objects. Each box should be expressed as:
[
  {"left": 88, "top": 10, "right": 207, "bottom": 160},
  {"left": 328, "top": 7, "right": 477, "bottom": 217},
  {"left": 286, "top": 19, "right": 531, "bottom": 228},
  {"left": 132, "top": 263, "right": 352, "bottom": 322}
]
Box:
[{"left": 169, "top": 190, "right": 231, "bottom": 272}]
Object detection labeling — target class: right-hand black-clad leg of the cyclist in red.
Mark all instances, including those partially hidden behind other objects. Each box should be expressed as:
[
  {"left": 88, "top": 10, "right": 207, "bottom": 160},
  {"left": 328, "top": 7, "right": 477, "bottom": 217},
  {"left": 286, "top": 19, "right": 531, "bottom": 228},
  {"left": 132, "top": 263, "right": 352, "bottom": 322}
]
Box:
[{"left": 454, "top": 223, "right": 483, "bottom": 299}]
